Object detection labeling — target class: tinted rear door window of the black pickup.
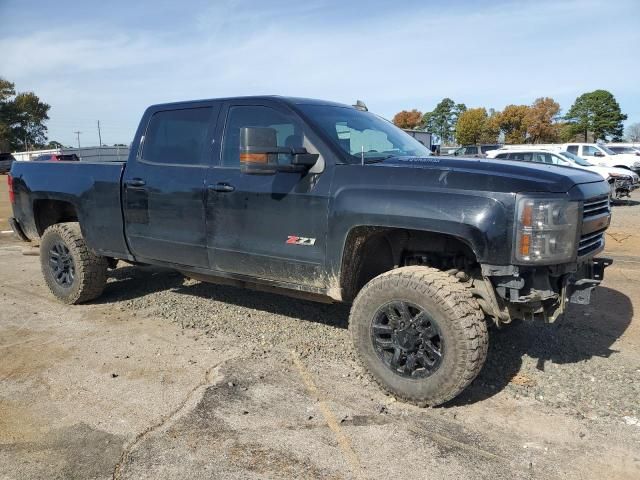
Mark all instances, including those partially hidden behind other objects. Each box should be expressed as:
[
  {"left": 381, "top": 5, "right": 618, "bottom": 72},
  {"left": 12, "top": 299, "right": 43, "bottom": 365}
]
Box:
[{"left": 142, "top": 107, "right": 213, "bottom": 165}]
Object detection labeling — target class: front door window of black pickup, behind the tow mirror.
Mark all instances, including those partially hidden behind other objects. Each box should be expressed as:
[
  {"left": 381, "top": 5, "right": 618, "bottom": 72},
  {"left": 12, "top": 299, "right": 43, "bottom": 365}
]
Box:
[{"left": 222, "top": 105, "right": 304, "bottom": 167}]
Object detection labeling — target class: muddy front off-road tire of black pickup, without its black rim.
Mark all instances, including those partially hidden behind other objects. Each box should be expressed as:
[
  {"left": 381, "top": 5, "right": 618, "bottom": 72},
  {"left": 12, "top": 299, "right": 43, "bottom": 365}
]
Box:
[{"left": 349, "top": 266, "right": 489, "bottom": 407}]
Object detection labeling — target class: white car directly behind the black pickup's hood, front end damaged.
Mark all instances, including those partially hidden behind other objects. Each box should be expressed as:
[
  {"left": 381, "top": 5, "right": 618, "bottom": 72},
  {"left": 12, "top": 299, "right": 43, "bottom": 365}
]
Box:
[{"left": 487, "top": 145, "right": 640, "bottom": 199}]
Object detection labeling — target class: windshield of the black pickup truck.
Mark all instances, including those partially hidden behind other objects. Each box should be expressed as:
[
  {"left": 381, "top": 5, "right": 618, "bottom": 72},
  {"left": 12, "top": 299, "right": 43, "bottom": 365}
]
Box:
[{"left": 299, "top": 105, "right": 431, "bottom": 162}]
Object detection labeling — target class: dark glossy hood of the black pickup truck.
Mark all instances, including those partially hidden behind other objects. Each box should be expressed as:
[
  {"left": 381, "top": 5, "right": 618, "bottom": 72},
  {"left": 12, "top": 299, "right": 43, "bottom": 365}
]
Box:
[{"left": 366, "top": 157, "right": 608, "bottom": 193}]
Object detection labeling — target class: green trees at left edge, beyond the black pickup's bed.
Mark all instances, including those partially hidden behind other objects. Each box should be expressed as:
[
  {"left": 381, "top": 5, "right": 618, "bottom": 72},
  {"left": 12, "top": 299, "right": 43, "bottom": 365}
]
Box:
[{"left": 0, "top": 78, "right": 50, "bottom": 151}]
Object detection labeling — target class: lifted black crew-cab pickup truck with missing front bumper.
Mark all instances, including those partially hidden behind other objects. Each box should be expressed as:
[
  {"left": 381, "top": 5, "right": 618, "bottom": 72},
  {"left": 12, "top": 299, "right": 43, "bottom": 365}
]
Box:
[{"left": 9, "top": 97, "right": 611, "bottom": 405}]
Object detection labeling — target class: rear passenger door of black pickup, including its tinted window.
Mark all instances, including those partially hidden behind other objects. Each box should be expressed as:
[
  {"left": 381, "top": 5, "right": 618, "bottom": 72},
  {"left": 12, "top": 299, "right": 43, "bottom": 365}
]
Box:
[{"left": 123, "top": 102, "right": 220, "bottom": 267}]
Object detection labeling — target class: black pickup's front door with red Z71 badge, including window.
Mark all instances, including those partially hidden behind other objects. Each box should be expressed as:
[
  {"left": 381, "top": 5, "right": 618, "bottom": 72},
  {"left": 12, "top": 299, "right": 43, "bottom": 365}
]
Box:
[{"left": 207, "top": 102, "right": 333, "bottom": 287}]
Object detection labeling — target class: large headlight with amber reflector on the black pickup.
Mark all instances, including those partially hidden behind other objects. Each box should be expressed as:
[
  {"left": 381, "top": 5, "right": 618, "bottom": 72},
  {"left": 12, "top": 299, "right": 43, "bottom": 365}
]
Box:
[{"left": 515, "top": 195, "right": 578, "bottom": 264}]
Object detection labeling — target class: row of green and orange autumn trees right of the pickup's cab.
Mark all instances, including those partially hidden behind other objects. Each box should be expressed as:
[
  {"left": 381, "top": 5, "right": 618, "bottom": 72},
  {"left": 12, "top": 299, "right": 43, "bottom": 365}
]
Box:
[{"left": 393, "top": 90, "right": 640, "bottom": 145}]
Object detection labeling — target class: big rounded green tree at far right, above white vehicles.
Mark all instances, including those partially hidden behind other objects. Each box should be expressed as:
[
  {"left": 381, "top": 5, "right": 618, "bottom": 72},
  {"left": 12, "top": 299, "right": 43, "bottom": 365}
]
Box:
[{"left": 565, "top": 90, "right": 627, "bottom": 141}]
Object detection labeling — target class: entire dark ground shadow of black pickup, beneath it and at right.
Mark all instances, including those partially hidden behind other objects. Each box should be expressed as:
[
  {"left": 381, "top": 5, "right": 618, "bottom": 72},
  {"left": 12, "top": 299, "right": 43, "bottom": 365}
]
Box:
[{"left": 96, "top": 267, "right": 633, "bottom": 407}]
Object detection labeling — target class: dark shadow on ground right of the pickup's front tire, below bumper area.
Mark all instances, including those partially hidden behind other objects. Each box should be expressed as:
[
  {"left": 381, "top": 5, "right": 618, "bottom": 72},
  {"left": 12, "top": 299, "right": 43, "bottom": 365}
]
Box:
[{"left": 445, "top": 287, "right": 633, "bottom": 407}]
